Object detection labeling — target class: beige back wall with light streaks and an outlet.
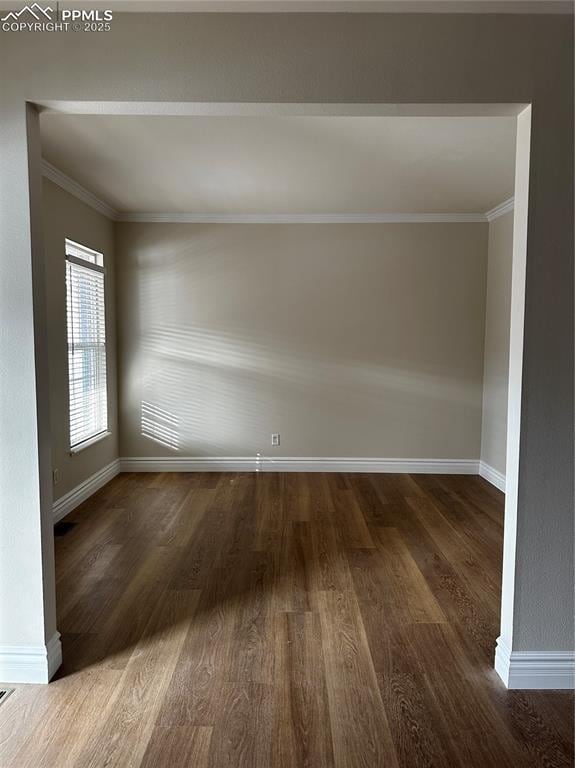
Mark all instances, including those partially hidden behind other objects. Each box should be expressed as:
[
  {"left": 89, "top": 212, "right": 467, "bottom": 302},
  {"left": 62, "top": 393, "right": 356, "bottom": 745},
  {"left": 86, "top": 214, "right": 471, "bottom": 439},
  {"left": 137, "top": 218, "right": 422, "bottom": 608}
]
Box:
[{"left": 117, "top": 224, "right": 487, "bottom": 459}]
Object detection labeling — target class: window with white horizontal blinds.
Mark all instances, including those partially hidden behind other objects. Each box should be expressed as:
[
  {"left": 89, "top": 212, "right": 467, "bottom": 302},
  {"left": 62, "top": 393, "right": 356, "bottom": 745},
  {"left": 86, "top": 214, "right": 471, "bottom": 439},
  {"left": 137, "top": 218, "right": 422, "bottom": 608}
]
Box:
[{"left": 66, "top": 240, "right": 108, "bottom": 451}]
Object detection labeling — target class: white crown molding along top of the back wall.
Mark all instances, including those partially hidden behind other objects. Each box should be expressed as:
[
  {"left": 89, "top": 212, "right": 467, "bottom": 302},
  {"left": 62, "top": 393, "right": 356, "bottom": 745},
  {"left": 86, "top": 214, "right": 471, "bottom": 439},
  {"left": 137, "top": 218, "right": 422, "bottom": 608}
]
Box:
[{"left": 117, "top": 213, "right": 487, "bottom": 224}]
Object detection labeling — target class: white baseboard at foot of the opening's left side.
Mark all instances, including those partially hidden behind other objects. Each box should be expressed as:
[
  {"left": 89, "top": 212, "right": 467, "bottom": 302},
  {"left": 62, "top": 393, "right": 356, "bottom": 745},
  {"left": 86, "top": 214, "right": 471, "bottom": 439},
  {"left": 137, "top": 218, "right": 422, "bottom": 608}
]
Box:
[{"left": 0, "top": 632, "right": 62, "bottom": 683}]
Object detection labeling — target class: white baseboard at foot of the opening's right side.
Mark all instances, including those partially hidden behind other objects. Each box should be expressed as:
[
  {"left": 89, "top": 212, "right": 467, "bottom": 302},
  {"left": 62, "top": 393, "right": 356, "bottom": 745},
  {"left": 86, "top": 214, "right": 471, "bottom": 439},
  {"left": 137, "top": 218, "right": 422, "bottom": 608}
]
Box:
[{"left": 495, "top": 637, "right": 575, "bottom": 690}]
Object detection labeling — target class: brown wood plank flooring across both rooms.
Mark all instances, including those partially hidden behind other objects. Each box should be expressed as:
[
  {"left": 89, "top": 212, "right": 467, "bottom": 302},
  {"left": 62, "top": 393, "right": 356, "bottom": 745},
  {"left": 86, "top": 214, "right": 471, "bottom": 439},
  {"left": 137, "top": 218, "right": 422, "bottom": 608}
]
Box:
[{"left": 0, "top": 473, "right": 573, "bottom": 768}]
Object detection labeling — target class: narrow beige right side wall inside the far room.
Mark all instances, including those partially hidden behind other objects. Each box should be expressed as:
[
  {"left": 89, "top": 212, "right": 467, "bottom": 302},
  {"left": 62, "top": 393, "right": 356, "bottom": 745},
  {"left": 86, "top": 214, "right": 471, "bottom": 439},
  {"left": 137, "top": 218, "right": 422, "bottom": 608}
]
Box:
[{"left": 481, "top": 212, "right": 513, "bottom": 475}]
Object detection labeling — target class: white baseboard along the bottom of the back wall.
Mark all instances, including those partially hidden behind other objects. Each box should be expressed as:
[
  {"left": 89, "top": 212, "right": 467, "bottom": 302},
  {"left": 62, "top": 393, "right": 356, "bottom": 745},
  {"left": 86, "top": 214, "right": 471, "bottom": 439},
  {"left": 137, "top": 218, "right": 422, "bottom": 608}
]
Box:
[{"left": 120, "top": 456, "right": 479, "bottom": 475}]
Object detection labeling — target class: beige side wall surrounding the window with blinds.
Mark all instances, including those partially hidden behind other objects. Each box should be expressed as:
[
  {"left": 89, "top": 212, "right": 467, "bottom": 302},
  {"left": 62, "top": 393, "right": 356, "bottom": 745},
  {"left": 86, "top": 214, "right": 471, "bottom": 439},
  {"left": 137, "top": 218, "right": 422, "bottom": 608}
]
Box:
[{"left": 42, "top": 179, "right": 118, "bottom": 499}]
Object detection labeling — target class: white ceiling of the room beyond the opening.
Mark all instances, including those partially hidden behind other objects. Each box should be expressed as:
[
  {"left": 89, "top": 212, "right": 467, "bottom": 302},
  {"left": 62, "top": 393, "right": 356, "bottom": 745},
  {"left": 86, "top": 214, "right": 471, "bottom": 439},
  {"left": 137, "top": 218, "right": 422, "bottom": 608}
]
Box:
[{"left": 41, "top": 113, "right": 515, "bottom": 215}]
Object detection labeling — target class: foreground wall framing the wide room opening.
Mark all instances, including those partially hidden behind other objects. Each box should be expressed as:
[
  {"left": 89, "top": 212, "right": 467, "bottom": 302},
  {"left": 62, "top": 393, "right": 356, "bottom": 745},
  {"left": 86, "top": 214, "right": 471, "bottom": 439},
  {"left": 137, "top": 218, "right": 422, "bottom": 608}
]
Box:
[{"left": 0, "top": 13, "right": 574, "bottom": 672}]
